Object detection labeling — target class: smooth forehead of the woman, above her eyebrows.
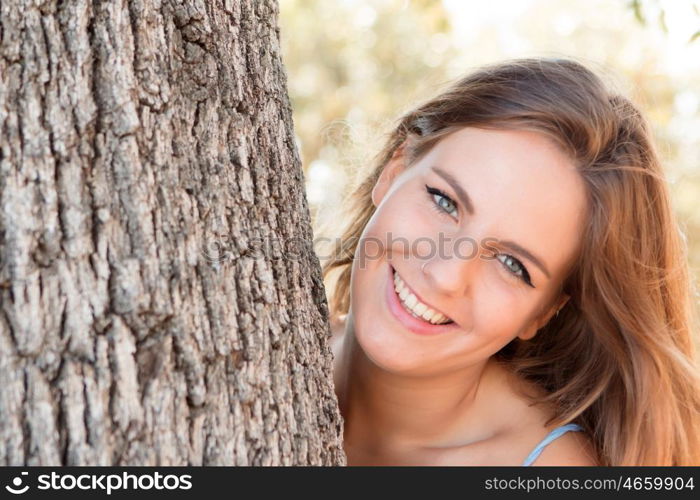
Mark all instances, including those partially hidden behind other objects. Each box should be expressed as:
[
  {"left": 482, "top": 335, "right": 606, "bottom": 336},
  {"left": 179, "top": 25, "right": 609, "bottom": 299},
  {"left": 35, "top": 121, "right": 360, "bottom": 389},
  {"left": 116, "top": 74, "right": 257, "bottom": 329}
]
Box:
[{"left": 419, "top": 127, "right": 586, "bottom": 282}]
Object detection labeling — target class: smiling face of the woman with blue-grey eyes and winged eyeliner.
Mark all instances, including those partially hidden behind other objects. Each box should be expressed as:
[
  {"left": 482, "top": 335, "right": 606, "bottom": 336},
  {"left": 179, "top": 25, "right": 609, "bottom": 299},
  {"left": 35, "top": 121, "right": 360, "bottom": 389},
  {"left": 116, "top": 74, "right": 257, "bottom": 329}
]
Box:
[{"left": 351, "top": 127, "right": 586, "bottom": 375}]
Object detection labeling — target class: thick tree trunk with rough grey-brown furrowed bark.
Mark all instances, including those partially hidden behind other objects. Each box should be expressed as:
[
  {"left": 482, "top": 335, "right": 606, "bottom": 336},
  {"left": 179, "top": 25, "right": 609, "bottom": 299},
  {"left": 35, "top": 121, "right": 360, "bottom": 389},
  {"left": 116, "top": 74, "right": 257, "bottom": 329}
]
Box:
[{"left": 0, "top": 0, "right": 345, "bottom": 465}]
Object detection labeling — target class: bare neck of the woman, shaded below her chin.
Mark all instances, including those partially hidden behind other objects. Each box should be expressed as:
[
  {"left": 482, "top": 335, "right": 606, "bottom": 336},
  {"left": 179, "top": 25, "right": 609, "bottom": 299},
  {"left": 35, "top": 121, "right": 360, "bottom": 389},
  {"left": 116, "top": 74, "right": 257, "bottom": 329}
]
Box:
[{"left": 335, "top": 318, "right": 493, "bottom": 454}]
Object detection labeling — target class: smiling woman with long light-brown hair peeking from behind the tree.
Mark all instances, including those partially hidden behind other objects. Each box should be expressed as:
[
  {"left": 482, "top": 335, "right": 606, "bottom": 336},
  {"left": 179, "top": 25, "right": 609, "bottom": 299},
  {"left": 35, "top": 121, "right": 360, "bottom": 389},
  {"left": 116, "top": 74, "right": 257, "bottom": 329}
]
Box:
[{"left": 323, "top": 59, "right": 700, "bottom": 465}]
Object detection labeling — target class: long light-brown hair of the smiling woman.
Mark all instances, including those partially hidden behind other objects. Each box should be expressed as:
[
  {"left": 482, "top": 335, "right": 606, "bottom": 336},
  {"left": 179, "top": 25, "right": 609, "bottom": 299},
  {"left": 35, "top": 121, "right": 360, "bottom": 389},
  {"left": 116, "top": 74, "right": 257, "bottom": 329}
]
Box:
[{"left": 323, "top": 58, "right": 700, "bottom": 465}]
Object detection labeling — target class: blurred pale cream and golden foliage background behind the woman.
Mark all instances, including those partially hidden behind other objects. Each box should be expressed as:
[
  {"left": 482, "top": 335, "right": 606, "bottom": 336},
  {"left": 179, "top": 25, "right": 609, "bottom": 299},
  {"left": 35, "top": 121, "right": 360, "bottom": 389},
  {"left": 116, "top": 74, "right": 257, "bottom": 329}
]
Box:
[{"left": 280, "top": 0, "right": 700, "bottom": 320}]
